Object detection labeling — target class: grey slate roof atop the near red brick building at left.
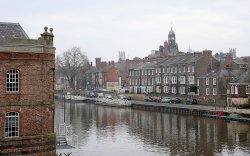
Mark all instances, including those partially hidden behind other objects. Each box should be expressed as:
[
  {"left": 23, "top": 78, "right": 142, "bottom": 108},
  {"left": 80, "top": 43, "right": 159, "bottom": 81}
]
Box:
[{"left": 0, "top": 22, "right": 29, "bottom": 39}]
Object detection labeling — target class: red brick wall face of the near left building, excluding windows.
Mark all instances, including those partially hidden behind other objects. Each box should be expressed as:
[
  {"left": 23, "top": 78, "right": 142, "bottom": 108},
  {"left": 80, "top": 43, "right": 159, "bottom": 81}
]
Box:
[{"left": 0, "top": 51, "right": 55, "bottom": 156}]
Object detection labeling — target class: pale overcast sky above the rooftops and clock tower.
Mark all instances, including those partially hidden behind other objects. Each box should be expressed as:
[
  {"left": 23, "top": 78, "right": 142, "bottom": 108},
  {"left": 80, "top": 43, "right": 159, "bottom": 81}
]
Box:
[{"left": 0, "top": 0, "right": 250, "bottom": 61}]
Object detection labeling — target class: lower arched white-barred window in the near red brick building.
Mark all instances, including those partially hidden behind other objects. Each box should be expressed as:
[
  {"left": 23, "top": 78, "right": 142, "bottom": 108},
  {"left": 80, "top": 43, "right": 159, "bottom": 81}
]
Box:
[{"left": 4, "top": 112, "right": 19, "bottom": 138}]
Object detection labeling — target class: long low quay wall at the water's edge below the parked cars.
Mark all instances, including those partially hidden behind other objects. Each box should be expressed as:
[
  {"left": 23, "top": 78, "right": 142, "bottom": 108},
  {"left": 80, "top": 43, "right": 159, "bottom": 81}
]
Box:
[{"left": 131, "top": 101, "right": 250, "bottom": 123}]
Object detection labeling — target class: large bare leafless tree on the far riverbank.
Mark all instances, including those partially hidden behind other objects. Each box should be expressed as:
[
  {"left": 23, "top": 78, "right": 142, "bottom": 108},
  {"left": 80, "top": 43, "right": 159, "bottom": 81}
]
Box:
[{"left": 56, "top": 47, "right": 88, "bottom": 89}]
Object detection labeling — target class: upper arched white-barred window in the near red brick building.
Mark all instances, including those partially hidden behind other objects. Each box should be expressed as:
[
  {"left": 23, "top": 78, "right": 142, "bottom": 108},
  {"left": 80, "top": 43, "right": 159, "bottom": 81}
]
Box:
[{"left": 6, "top": 69, "right": 19, "bottom": 92}]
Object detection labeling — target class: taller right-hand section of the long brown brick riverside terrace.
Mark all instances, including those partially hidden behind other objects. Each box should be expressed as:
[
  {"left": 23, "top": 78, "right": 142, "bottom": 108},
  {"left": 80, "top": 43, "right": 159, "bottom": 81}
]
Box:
[{"left": 155, "top": 50, "right": 219, "bottom": 95}]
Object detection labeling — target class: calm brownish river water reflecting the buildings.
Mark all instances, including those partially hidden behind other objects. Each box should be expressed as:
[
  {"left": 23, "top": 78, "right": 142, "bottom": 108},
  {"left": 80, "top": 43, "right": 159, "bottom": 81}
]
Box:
[{"left": 55, "top": 101, "right": 250, "bottom": 156}]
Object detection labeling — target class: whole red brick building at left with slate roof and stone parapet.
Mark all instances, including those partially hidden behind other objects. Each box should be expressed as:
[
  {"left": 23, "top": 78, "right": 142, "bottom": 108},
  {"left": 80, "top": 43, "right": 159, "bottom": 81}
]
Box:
[{"left": 0, "top": 23, "right": 56, "bottom": 156}]
